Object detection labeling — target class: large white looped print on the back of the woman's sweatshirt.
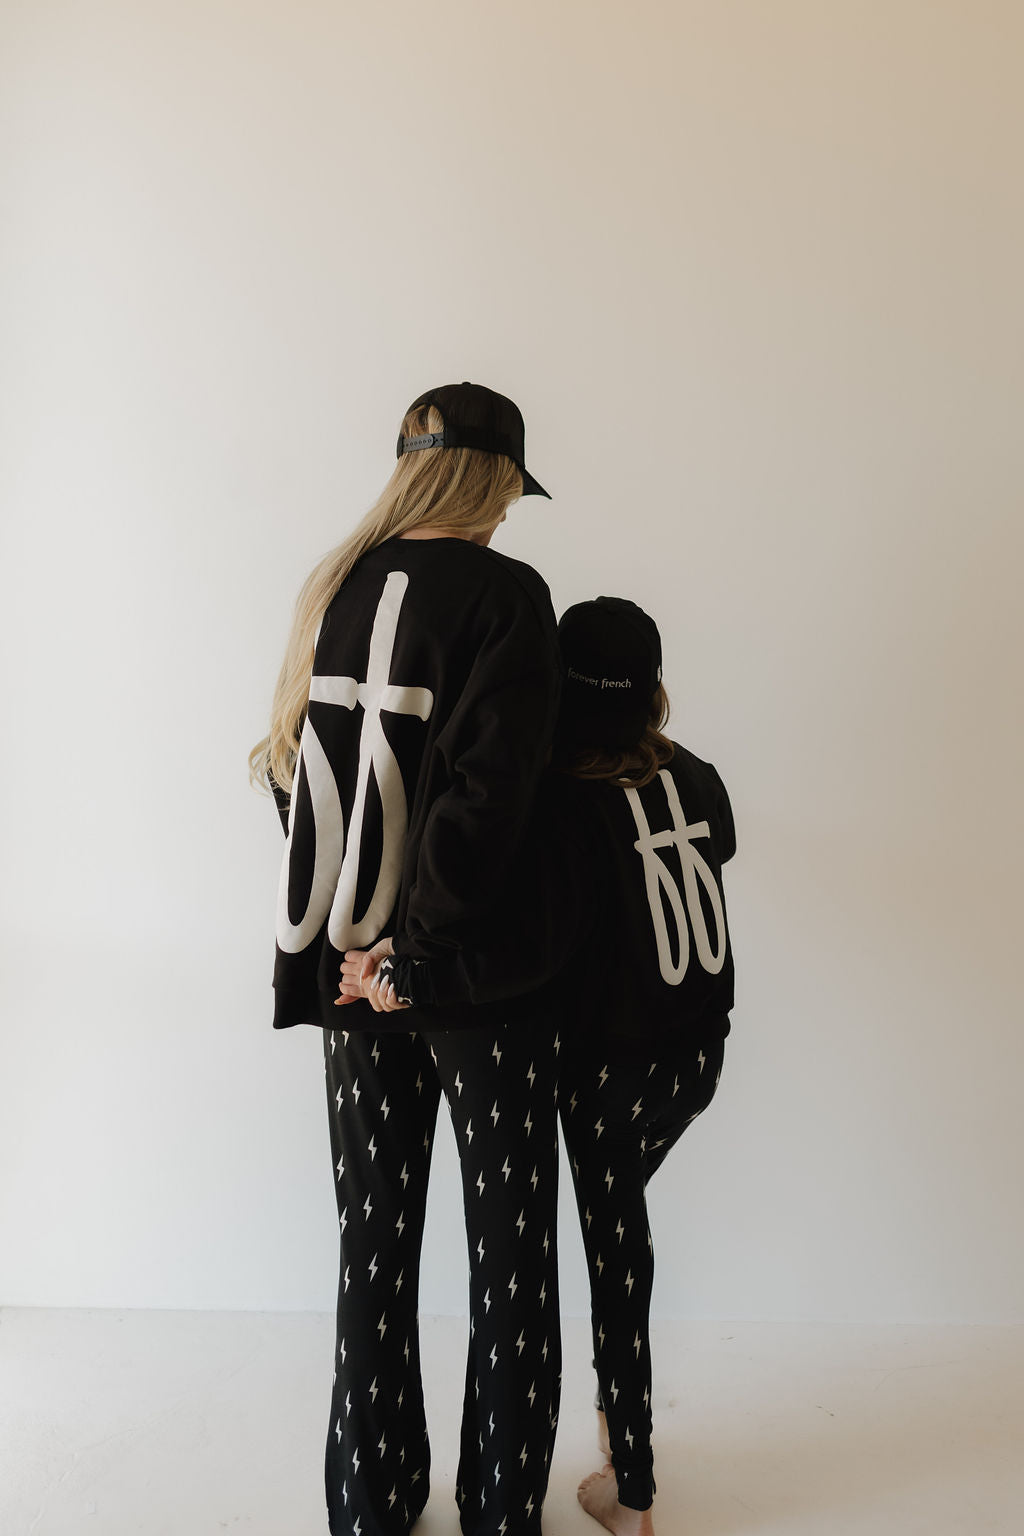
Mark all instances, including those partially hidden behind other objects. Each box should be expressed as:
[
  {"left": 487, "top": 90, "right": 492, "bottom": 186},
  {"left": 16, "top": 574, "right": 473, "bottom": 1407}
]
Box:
[{"left": 278, "top": 571, "right": 434, "bottom": 954}]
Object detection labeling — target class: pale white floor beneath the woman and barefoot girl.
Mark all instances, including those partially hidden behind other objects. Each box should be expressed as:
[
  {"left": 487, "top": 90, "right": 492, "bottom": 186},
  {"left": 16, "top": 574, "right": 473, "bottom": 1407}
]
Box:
[{"left": 0, "top": 1310, "right": 1024, "bottom": 1536}]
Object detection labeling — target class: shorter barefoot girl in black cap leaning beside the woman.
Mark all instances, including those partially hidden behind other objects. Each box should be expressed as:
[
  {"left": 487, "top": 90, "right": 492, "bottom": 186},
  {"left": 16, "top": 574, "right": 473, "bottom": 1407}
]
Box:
[{"left": 559, "top": 598, "right": 735, "bottom": 1536}]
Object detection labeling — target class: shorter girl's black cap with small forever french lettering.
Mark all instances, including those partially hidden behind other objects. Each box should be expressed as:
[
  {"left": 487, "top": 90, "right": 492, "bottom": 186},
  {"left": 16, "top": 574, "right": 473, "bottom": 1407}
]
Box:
[{"left": 559, "top": 598, "right": 662, "bottom": 748}]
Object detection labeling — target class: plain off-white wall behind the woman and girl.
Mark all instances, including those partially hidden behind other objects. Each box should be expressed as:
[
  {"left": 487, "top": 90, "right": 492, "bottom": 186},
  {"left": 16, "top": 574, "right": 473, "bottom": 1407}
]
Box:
[{"left": 0, "top": 0, "right": 1024, "bottom": 1321}]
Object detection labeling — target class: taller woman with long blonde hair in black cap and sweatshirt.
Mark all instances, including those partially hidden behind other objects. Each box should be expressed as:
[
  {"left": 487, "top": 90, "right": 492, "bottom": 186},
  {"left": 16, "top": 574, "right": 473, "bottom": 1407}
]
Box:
[{"left": 250, "top": 384, "right": 560, "bottom": 1536}]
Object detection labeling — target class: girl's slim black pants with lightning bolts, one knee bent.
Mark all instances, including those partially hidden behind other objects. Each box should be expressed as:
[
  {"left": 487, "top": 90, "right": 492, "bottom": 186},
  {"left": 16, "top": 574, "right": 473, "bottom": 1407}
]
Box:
[{"left": 559, "top": 1040, "right": 725, "bottom": 1510}]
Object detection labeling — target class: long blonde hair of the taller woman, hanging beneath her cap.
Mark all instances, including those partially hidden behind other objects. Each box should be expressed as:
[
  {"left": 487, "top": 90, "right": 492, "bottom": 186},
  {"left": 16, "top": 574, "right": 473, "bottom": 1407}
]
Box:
[{"left": 249, "top": 406, "right": 522, "bottom": 790}]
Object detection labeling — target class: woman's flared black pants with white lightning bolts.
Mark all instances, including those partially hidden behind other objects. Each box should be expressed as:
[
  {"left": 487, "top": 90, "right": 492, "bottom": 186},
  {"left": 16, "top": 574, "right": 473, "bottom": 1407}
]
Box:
[{"left": 324, "top": 1018, "right": 560, "bottom": 1536}]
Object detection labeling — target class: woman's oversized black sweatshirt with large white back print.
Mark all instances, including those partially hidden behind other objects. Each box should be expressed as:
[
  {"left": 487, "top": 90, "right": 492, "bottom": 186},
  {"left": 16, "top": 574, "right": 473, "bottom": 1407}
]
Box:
[{"left": 273, "top": 539, "right": 559, "bottom": 1029}]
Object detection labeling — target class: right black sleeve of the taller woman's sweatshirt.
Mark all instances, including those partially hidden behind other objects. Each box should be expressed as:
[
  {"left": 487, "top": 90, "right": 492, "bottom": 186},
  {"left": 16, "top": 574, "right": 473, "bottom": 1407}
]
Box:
[{"left": 395, "top": 574, "right": 559, "bottom": 960}]
